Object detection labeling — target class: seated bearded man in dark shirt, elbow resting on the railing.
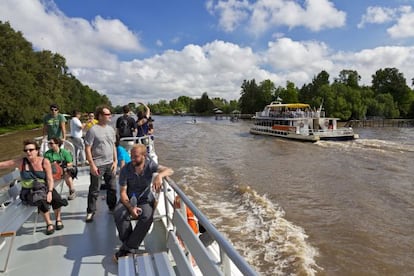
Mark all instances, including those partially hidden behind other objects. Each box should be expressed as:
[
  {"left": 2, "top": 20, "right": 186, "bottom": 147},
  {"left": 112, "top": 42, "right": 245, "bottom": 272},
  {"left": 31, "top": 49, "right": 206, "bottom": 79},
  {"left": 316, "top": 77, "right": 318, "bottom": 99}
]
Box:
[{"left": 114, "top": 144, "right": 173, "bottom": 262}]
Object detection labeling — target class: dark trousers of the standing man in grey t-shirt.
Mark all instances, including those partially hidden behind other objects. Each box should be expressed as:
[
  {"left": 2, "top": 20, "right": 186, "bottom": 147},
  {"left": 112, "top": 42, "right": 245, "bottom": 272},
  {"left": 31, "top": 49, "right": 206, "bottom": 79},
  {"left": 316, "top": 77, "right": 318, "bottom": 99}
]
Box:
[{"left": 86, "top": 163, "right": 117, "bottom": 213}]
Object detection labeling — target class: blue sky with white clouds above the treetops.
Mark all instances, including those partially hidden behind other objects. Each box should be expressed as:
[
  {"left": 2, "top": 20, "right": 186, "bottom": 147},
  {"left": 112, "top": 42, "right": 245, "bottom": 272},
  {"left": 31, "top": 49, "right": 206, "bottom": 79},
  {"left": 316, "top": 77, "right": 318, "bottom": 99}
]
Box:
[{"left": 0, "top": 0, "right": 414, "bottom": 105}]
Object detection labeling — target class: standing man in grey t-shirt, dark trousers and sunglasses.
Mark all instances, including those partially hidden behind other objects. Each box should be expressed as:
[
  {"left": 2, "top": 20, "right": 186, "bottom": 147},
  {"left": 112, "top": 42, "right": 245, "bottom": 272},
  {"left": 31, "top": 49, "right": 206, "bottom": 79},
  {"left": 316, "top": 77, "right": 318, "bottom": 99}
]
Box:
[{"left": 85, "top": 106, "right": 118, "bottom": 222}]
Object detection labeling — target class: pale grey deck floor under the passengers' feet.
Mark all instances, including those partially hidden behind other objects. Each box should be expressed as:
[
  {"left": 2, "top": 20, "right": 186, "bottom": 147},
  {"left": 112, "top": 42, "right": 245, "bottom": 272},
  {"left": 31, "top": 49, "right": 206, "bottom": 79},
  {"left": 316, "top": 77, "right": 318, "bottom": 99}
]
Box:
[{"left": 0, "top": 176, "right": 120, "bottom": 276}]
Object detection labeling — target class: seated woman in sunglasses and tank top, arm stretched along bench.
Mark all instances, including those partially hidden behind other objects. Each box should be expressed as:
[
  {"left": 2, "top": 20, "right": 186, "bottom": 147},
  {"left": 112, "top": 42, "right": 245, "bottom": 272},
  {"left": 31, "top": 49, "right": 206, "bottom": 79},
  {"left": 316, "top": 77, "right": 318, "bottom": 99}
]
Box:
[{"left": 0, "top": 140, "right": 68, "bottom": 235}]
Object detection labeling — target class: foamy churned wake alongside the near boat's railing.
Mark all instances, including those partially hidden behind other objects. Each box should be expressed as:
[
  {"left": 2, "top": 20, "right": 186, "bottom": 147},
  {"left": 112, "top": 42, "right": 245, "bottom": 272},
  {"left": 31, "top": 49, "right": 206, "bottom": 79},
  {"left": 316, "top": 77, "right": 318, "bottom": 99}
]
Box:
[{"left": 175, "top": 167, "right": 322, "bottom": 275}]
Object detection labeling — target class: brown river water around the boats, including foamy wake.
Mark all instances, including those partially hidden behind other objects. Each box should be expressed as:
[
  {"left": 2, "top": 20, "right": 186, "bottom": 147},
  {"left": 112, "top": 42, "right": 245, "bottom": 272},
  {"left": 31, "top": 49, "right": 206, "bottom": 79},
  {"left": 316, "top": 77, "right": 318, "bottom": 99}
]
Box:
[{"left": 0, "top": 116, "right": 414, "bottom": 275}]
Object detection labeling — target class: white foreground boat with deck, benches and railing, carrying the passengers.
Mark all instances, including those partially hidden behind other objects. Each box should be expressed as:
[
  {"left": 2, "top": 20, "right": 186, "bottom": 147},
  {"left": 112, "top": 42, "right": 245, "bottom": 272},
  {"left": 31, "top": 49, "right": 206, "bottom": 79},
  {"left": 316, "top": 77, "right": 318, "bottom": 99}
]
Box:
[{"left": 0, "top": 138, "right": 257, "bottom": 276}]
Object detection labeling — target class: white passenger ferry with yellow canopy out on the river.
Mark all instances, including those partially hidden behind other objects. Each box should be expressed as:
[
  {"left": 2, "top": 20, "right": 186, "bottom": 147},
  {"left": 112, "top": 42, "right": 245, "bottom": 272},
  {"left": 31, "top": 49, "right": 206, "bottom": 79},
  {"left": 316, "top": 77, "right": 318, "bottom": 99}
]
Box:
[{"left": 250, "top": 102, "right": 358, "bottom": 142}]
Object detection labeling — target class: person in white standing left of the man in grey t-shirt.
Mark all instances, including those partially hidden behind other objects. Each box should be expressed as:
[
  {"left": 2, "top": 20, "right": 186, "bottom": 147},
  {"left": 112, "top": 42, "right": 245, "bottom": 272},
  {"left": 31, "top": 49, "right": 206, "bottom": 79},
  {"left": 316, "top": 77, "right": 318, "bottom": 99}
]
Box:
[{"left": 70, "top": 110, "right": 86, "bottom": 165}]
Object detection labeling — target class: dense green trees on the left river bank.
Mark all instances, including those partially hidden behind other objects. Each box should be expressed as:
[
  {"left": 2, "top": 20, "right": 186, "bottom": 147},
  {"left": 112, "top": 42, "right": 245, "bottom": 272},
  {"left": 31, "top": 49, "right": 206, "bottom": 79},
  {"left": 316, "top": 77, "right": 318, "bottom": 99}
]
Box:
[{"left": 0, "top": 21, "right": 111, "bottom": 126}]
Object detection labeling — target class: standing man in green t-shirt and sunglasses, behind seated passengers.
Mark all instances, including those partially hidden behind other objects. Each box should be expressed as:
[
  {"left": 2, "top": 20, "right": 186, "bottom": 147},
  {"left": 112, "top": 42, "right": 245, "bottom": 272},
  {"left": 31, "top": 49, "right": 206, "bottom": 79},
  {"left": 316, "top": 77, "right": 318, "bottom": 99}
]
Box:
[{"left": 43, "top": 104, "right": 66, "bottom": 140}]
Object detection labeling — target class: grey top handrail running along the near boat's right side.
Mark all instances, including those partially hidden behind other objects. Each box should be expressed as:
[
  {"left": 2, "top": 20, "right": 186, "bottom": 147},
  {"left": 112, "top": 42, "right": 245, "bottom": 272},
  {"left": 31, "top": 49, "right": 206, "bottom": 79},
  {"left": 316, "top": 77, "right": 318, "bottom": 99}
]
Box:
[{"left": 166, "top": 177, "right": 258, "bottom": 275}]
